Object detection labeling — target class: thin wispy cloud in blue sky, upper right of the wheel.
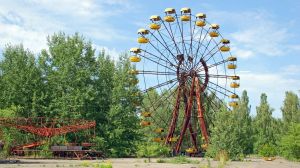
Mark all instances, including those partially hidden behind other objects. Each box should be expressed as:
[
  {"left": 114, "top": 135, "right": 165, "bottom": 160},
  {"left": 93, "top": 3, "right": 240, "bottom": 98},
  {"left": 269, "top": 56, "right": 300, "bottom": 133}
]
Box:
[{"left": 209, "top": 10, "right": 300, "bottom": 59}]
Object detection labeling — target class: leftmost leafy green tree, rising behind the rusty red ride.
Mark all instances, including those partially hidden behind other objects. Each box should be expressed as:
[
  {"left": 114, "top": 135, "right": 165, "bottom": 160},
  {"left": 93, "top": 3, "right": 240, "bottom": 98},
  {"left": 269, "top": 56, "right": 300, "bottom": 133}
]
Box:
[{"left": 0, "top": 45, "right": 43, "bottom": 117}]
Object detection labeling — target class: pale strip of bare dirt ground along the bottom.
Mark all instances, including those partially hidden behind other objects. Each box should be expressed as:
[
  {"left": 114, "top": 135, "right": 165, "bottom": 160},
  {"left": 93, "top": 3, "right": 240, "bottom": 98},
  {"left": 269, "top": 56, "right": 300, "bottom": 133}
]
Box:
[{"left": 0, "top": 158, "right": 300, "bottom": 168}]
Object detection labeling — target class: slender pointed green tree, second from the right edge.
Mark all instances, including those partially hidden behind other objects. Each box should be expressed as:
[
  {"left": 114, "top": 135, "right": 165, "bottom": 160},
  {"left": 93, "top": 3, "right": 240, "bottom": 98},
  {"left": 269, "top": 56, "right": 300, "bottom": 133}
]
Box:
[{"left": 254, "top": 93, "right": 278, "bottom": 152}]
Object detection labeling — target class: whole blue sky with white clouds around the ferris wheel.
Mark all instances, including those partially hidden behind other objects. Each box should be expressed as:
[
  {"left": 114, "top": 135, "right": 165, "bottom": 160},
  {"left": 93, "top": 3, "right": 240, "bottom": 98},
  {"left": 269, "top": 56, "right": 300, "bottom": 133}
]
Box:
[{"left": 0, "top": 0, "right": 300, "bottom": 117}]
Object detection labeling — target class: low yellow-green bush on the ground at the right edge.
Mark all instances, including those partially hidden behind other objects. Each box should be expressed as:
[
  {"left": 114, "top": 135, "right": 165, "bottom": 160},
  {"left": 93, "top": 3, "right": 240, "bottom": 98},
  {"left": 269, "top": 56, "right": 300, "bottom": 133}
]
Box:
[{"left": 280, "top": 123, "right": 300, "bottom": 161}]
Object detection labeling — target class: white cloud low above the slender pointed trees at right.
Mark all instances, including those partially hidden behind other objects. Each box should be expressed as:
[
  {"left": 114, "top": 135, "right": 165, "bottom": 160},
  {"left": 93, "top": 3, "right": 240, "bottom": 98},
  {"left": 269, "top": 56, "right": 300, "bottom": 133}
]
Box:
[{"left": 238, "top": 71, "right": 300, "bottom": 117}]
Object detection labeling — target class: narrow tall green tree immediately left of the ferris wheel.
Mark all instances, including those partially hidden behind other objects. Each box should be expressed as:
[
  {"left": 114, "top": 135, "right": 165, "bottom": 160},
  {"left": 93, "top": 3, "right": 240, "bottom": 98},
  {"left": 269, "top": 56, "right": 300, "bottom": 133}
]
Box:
[{"left": 107, "top": 55, "right": 141, "bottom": 157}]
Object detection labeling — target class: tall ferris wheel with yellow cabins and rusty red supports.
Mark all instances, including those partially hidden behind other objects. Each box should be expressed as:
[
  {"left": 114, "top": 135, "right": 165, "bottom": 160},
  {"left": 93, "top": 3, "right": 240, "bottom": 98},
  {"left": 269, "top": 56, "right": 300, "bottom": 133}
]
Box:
[{"left": 130, "top": 8, "right": 240, "bottom": 154}]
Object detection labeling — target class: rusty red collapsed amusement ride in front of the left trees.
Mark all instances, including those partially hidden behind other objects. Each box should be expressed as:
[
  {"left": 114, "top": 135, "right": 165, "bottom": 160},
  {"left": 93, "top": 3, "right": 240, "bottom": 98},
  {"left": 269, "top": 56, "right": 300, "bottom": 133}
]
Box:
[{"left": 0, "top": 117, "right": 102, "bottom": 159}]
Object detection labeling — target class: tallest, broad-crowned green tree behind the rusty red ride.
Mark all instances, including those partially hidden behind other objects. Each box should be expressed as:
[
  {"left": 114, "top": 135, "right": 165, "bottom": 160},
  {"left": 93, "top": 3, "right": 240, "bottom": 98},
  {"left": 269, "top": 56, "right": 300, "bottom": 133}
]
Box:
[{"left": 39, "top": 33, "right": 96, "bottom": 118}]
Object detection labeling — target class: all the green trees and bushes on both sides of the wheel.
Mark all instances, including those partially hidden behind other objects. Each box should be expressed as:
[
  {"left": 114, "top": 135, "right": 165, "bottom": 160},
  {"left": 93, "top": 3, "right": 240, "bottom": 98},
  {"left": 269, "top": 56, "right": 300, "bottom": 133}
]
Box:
[{"left": 0, "top": 33, "right": 300, "bottom": 162}]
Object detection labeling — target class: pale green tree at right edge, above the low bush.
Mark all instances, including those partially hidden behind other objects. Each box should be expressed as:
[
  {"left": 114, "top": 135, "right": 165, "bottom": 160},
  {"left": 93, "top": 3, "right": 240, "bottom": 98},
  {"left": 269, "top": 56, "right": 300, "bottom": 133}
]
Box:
[{"left": 281, "top": 92, "right": 300, "bottom": 125}]
